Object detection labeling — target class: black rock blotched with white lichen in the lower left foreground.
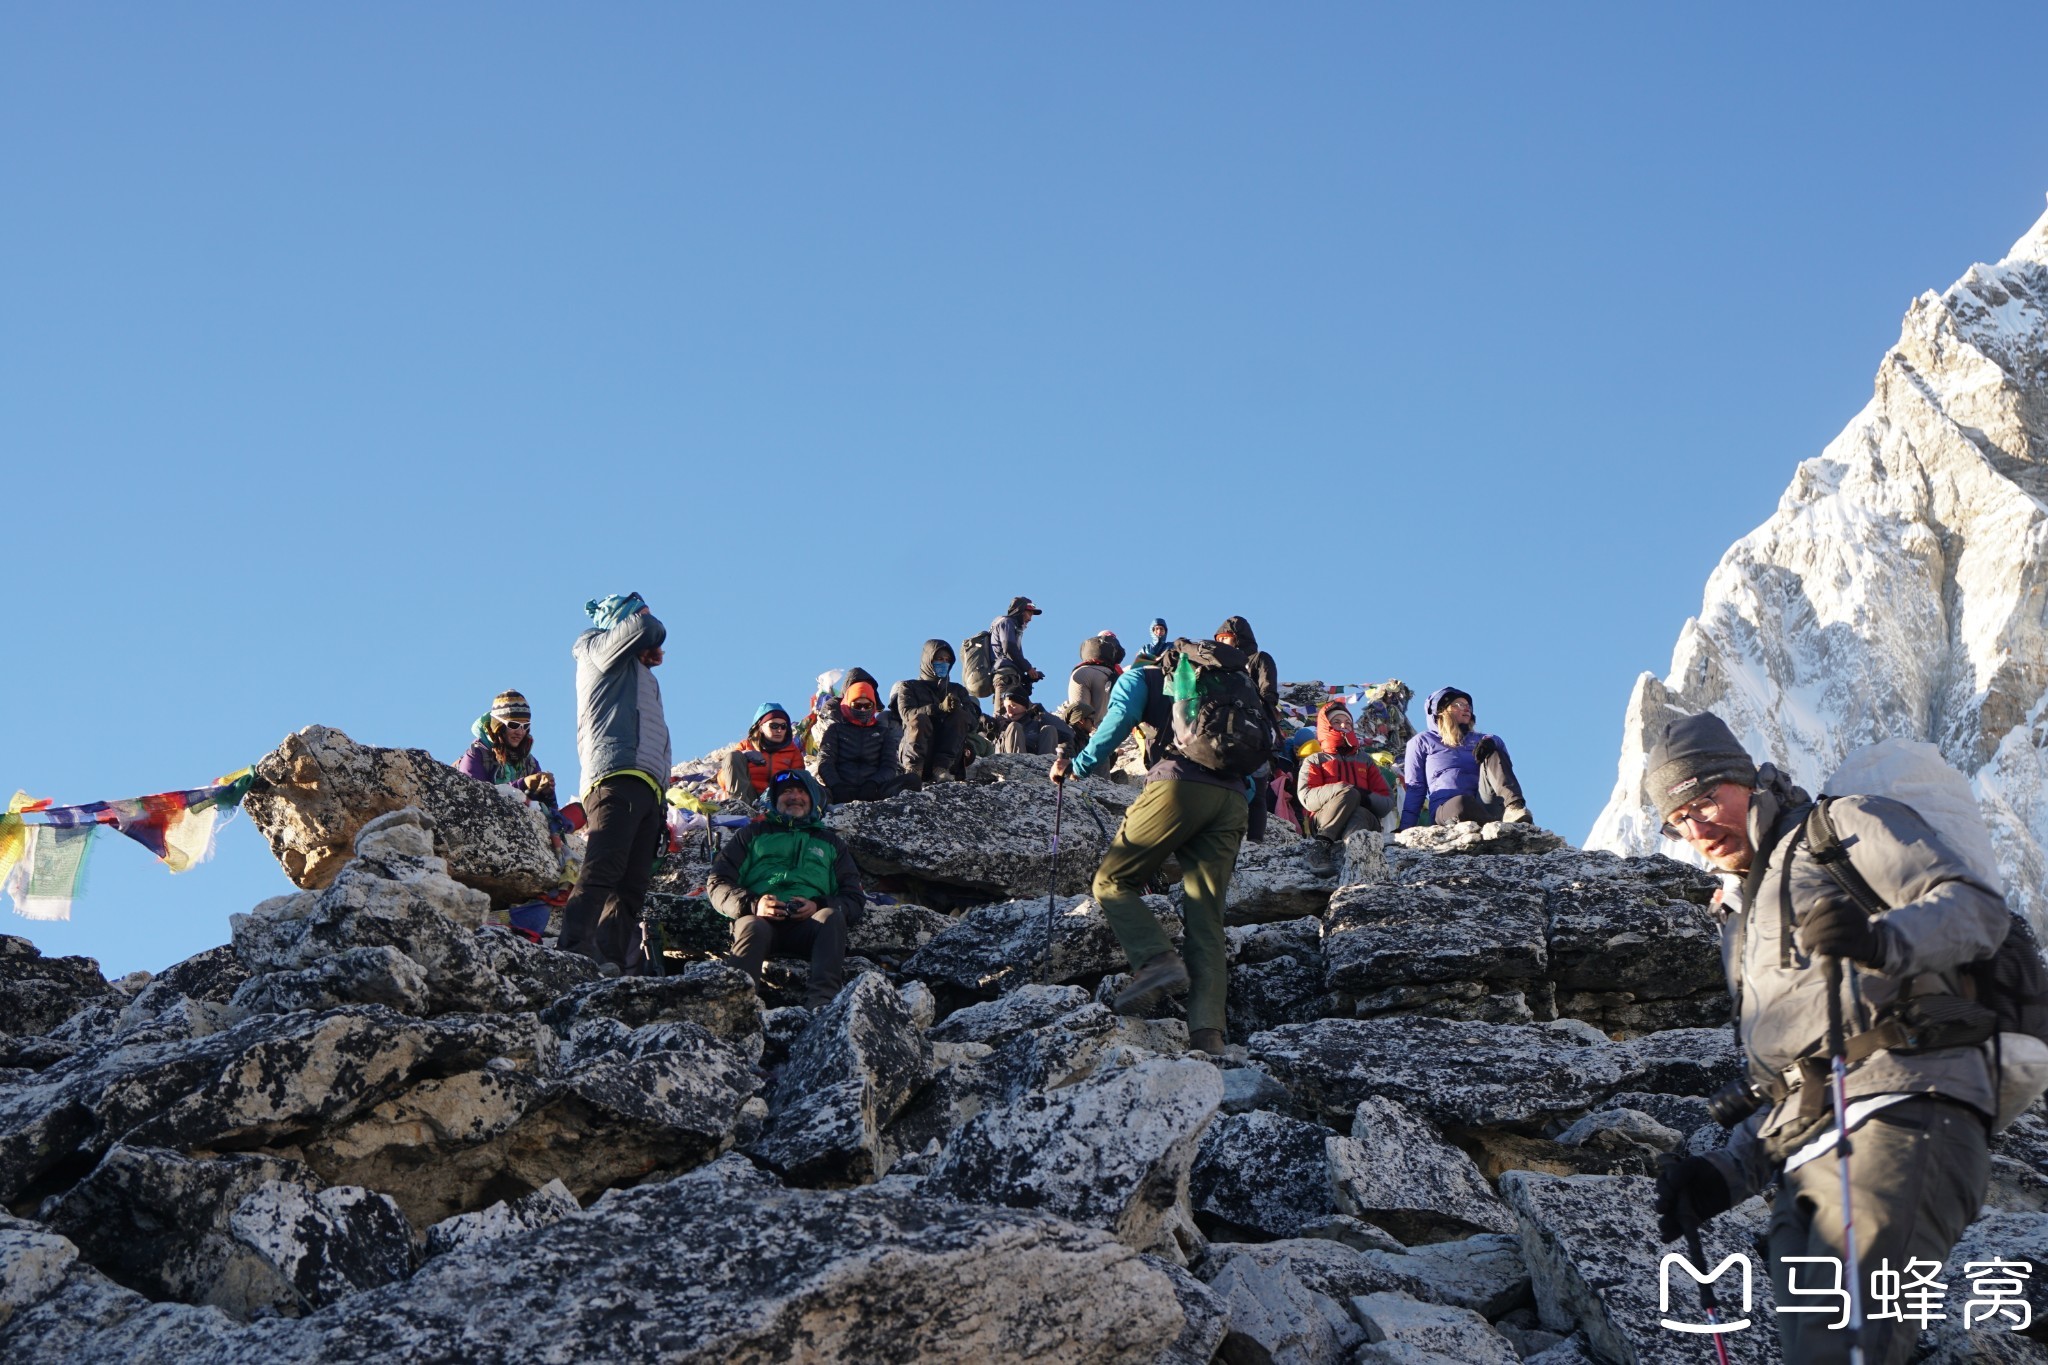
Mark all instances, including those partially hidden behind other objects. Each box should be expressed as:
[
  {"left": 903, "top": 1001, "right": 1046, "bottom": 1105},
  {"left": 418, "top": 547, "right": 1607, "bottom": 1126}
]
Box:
[{"left": 227, "top": 1181, "right": 412, "bottom": 1312}]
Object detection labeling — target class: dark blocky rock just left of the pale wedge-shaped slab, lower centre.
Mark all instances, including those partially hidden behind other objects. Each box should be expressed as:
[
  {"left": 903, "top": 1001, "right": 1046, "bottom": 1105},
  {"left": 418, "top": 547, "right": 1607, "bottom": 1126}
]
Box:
[{"left": 1188, "top": 1113, "right": 1339, "bottom": 1242}]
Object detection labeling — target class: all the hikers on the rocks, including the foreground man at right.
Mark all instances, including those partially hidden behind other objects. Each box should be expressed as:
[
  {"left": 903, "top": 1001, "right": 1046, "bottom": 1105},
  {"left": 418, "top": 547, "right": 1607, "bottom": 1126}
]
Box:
[{"left": 448, "top": 593, "right": 2048, "bottom": 1365}]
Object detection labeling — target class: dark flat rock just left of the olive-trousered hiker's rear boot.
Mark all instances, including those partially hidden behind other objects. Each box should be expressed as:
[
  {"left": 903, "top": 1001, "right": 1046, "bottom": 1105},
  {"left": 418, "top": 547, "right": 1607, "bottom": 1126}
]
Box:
[{"left": 901, "top": 896, "right": 1180, "bottom": 1001}]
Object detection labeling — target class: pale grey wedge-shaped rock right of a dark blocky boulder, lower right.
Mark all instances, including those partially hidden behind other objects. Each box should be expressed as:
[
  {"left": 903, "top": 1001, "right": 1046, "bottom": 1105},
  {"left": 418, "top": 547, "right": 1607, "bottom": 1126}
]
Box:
[{"left": 1327, "top": 1095, "right": 1516, "bottom": 1244}]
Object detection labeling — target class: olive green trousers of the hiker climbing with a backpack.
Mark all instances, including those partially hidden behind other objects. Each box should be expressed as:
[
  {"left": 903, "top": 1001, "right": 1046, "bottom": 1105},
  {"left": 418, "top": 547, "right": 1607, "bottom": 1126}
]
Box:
[{"left": 1094, "top": 780, "right": 1251, "bottom": 1031}]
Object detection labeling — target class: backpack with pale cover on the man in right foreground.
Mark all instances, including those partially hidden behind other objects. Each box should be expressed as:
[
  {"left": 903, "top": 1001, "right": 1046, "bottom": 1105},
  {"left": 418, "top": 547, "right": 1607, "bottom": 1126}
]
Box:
[{"left": 1802, "top": 739, "right": 2048, "bottom": 1132}]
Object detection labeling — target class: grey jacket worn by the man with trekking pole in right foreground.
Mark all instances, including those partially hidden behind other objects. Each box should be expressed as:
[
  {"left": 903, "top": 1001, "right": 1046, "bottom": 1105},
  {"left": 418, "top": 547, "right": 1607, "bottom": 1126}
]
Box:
[{"left": 1714, "top": 767, "right": 2011, "bottom": 1199}]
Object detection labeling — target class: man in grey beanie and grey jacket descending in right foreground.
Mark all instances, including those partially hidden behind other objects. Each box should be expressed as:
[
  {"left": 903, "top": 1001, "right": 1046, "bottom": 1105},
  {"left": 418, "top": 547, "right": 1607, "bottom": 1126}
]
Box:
[{"left": 1649, "top": 712, "right": 2013, "bottom": 1365}]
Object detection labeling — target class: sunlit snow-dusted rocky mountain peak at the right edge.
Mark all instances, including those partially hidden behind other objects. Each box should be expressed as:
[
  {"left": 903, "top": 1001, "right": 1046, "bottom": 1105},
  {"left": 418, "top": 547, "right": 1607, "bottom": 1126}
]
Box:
[{"left": 1585, "top": 200, "right": 2048, "bottom": 927}]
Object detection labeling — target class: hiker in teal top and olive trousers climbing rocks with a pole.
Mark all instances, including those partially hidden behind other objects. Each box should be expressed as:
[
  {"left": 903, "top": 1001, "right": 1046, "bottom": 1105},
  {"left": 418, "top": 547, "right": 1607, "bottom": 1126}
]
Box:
[{"left": 1053, "top": 641, "right": 1274, "bottom": 1056}]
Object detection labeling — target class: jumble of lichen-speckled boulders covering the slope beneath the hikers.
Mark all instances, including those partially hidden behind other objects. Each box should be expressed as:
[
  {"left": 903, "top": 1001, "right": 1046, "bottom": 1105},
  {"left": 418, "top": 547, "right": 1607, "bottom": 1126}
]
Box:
[{"left": 0, "top": 726, "right": 2048, "bottom": 1365}]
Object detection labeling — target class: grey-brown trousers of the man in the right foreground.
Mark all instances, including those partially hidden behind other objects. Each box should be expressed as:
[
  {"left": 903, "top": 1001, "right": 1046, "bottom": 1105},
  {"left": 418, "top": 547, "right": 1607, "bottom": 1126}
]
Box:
[{"left": 1769, "top": 1095, "right": 2003, "bottom": 1365}]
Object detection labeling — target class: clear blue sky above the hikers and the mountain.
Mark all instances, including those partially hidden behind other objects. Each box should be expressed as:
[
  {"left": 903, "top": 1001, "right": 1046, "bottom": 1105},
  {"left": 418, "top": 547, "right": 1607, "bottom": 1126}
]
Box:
[{"left": 0, "top": 2, "right": 2048, "bottom": 972}]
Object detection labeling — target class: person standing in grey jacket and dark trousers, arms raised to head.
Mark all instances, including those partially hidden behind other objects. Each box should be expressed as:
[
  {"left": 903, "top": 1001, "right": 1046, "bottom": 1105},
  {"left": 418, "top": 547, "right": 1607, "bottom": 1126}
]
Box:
[{"left": 561, "top": 593, "right": 670, "bottom": 976}]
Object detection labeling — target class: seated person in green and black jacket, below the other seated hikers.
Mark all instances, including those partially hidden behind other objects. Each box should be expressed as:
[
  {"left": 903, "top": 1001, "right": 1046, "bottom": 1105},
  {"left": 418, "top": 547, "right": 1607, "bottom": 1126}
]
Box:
[{"left": 705, "top": 769, "right": 866, "bottom": 1009}]
